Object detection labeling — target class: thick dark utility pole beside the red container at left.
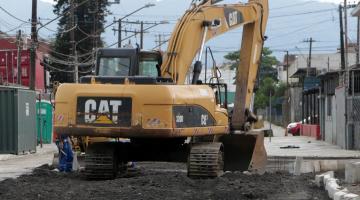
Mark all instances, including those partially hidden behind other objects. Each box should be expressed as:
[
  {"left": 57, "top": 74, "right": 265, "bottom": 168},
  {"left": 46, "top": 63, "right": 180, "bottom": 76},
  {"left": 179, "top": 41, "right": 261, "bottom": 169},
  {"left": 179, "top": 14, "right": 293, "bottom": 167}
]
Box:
[{"left": 29, "top": 0, "right": 37, "bottom": 90}]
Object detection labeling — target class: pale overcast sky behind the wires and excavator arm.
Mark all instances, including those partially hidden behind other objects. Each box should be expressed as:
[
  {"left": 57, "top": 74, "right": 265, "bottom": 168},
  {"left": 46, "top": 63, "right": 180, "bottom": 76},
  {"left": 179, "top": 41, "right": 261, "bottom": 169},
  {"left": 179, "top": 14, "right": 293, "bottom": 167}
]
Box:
[{"left": 0, "top": 0, "right": 357, "bottom": 62}]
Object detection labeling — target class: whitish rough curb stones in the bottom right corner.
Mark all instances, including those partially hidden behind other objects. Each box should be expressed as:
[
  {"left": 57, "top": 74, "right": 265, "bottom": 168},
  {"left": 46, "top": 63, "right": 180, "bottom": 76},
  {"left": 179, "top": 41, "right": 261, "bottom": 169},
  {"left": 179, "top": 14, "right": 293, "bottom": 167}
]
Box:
[{"left": 315, "top": 171, "right": 360, "bottom": 200}]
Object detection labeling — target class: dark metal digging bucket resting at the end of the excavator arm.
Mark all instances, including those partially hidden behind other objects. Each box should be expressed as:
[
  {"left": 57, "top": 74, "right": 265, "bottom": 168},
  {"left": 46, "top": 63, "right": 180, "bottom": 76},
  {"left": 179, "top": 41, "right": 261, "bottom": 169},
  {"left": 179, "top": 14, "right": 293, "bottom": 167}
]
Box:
[{"left": 220, "top": 131, "right": 267, "bottom": 174}]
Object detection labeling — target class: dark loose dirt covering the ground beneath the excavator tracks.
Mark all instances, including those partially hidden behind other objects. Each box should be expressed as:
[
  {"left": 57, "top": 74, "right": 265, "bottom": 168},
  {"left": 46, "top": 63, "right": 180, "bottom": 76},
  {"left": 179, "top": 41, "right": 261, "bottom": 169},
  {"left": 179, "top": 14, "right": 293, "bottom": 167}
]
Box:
[{"left": 0, "top": 163, "right": 328, "bottom": 200}]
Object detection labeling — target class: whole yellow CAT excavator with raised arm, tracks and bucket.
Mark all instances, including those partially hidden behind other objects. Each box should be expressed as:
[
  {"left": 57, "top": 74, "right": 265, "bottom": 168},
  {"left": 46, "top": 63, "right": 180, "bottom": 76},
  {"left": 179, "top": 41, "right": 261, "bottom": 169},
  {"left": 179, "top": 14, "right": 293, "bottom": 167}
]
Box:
[{"left": 54, "top": 0, "right": 268, "bottom": 179}]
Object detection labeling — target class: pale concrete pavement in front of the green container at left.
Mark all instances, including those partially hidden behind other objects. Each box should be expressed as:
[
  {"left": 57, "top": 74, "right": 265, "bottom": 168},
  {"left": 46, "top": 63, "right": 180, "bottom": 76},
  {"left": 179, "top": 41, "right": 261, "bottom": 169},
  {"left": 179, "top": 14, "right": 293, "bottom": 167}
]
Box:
[{"left": 0, "top": 144, "right": 57, "bottom": 181}]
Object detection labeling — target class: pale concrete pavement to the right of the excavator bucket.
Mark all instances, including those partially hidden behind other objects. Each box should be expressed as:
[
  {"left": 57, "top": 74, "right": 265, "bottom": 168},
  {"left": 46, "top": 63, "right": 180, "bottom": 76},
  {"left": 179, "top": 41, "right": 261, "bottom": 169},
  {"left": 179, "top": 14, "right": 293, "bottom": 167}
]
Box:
[{"left": 264, "top": 136, "right": 360, "bottom": 174}]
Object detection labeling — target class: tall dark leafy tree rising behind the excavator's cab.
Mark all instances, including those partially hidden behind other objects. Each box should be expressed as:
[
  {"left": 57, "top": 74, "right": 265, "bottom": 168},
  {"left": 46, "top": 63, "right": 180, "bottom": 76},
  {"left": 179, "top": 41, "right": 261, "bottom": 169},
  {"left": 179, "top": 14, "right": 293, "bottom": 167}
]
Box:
[{"left": 45, "top": 0, "right": 108, "bottom": 82}]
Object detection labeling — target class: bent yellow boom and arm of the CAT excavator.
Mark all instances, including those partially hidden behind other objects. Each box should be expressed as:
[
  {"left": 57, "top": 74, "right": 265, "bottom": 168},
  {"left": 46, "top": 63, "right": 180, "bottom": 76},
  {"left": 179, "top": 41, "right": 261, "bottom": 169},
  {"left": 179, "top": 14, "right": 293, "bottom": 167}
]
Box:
[{"left": 161, "top": 0, "right": 268, "bottom": 130}]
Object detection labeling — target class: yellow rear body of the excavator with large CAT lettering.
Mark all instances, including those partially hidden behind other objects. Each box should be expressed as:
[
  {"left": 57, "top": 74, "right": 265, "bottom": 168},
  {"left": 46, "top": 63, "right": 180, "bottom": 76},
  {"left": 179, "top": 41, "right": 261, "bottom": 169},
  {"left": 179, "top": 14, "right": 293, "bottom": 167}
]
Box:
[{"left": 55, "top": 84, "right": 229, "bottom": 138}]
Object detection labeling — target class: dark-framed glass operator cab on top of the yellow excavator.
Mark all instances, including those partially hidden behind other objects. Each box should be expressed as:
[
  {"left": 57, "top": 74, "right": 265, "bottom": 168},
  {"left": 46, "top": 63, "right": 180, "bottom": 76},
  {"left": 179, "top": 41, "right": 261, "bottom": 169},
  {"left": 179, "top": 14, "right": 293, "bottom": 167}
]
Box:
[{"left": 80, "top": 48, "right": 173, "bottom": 85}]
